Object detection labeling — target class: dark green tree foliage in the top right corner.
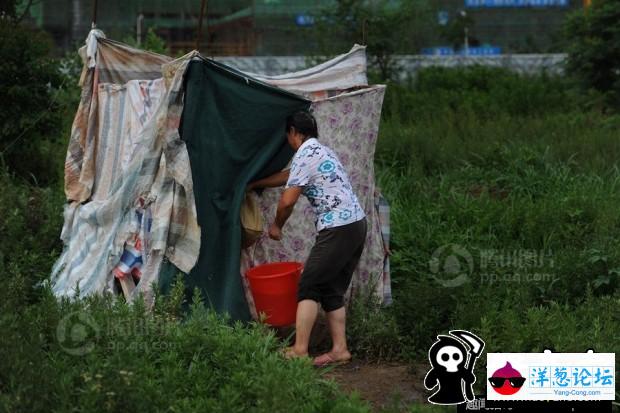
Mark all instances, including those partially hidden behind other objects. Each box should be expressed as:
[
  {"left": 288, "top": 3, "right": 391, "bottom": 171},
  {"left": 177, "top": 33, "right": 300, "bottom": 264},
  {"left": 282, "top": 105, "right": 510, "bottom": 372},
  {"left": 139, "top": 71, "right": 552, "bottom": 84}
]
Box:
[{"left": 565, "top": 0, "right": 620, "bottom": 107}]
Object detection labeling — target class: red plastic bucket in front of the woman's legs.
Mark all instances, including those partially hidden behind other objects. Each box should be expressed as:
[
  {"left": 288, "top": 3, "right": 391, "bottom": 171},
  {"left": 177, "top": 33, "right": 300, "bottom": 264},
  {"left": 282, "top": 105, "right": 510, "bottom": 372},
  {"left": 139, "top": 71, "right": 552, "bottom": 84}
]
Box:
[{"left": 246, "top": 262, "right": 303, "bottom": 327}]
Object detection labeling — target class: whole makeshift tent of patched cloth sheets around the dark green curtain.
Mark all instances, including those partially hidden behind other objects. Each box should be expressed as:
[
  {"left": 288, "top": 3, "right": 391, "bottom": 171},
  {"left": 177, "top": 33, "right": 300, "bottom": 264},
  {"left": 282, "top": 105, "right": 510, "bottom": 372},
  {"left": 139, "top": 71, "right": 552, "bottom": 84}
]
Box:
[{"left": 52, "top": 31, "right": 385, "bottom": 319}]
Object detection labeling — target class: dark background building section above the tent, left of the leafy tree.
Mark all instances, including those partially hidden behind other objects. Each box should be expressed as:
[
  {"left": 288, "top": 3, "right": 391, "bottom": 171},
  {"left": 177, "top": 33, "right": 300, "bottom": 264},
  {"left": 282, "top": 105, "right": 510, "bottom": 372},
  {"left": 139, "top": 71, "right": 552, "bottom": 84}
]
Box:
[{"left": 31, "top": 0, "right": 330, "bottom": 55}]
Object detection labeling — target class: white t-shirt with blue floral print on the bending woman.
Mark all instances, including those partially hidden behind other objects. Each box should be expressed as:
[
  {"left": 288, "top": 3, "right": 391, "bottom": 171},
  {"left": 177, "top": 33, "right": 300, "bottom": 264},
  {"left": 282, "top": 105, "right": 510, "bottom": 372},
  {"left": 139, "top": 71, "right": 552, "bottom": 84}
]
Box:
[{"left": 286, "top": 138, "right": 366, "bottom": 231}]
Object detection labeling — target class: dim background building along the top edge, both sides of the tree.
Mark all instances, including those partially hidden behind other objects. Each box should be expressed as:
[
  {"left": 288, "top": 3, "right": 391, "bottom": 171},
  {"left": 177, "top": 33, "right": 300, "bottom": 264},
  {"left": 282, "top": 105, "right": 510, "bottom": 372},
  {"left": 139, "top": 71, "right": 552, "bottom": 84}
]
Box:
[{"left": 31, "top": 0, "right": 582, "bottom": 56}]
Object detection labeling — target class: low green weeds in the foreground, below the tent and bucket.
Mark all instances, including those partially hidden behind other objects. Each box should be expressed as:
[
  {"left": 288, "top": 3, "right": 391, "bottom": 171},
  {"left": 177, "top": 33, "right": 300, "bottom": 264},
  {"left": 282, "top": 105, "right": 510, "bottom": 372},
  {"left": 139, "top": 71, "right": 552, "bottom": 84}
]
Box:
[{"left": 0, "top": 280, "right": 368, "bottom": 412}]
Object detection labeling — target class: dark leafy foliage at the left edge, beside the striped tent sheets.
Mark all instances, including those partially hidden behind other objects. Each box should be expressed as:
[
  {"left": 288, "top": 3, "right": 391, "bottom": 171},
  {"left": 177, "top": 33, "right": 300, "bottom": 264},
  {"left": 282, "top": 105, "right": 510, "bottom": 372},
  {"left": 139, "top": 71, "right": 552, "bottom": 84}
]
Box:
[{"left": 0, "top": 19, "right": 79, "bottom": 184}]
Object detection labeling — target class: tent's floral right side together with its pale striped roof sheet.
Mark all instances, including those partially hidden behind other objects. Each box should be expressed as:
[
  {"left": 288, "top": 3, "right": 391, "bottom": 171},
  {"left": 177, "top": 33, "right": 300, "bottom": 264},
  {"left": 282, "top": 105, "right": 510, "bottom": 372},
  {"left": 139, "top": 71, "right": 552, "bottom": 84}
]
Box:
[{"left": 235, "top": 45, "right": 391, "bottom": 316}]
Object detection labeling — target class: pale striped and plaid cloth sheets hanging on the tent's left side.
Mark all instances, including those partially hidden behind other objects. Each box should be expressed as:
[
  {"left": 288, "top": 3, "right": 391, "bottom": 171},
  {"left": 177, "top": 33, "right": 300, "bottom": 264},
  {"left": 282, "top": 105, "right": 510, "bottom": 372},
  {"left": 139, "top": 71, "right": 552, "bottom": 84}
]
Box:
[{"left": 51, "top": 32, "right": 200, "bottom": 299}]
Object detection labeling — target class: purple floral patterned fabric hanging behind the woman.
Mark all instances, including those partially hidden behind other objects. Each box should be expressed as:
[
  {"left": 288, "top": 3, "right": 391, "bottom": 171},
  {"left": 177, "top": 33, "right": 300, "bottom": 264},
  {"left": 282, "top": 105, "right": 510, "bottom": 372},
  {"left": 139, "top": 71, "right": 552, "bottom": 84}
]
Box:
[{"left": 241, "top": 86, "right": 385, "bottom": 316}]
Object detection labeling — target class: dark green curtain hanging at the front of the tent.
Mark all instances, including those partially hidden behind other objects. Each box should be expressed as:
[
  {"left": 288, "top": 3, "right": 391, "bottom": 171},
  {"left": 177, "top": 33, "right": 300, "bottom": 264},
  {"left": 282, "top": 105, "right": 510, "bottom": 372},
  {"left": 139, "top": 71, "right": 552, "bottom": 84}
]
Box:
[{"left": 168, "top": 59, "right": 310, "bottom": 320}]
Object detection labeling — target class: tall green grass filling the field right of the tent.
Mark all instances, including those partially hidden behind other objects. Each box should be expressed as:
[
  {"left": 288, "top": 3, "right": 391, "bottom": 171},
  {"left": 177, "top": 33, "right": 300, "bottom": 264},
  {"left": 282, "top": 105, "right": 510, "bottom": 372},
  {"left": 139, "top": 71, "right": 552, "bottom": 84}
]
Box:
[{"left": 376, "top": 68, "right": 620, "bottom": 366}]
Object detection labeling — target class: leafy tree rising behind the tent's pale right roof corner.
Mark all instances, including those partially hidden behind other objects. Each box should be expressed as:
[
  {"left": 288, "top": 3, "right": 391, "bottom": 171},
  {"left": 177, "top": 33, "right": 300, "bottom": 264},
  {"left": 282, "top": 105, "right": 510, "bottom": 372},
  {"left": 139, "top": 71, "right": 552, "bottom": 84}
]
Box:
[{"left": 314, "top": 0, "right": 433, "bottom": 80}]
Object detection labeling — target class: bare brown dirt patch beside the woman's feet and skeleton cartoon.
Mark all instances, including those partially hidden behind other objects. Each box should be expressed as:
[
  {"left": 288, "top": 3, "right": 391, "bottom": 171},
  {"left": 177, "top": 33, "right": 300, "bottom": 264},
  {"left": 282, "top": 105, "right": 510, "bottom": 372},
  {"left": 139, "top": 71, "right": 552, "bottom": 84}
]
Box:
[{"left": 325, "top": 361, "right": 425, "bottom": 411}]
